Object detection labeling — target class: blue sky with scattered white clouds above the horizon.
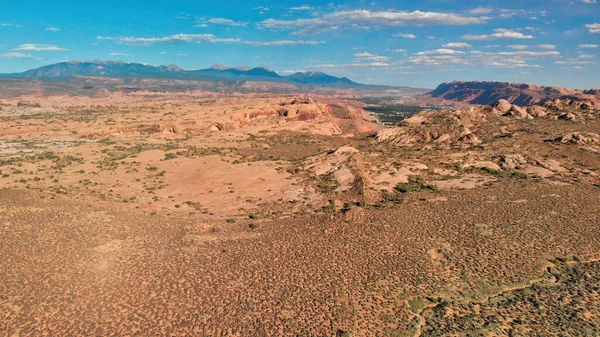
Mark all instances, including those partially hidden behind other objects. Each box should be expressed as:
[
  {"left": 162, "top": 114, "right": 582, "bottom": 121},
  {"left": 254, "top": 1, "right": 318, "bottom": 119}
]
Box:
[{"left": 0, "top": 0, "right": 600, "bottom": 88}]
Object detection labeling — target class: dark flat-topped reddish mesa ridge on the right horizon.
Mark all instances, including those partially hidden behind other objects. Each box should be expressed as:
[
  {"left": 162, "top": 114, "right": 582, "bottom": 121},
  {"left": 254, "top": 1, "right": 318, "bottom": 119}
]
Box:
[{"left": 423, "top": 81, "right": 600, "bottom": 106}]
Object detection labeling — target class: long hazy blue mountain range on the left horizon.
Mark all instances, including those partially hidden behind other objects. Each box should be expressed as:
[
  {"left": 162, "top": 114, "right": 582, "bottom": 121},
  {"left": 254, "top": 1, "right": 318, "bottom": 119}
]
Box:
[{"left": 0, "top": 61, "right": 363, "bottom": 88}]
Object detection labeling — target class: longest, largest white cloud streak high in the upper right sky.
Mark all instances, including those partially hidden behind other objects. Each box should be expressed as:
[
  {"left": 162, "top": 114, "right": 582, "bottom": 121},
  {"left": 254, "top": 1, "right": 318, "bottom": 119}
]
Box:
[{"left": 258, "top": 10, "right": 488, "bottom": 34}]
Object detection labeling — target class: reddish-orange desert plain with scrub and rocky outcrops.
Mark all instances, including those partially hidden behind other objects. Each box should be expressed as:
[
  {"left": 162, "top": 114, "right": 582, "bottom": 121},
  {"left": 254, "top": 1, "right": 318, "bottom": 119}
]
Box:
[{"left": 0, "top": 90, "right": 600, "bottom": 337}]
